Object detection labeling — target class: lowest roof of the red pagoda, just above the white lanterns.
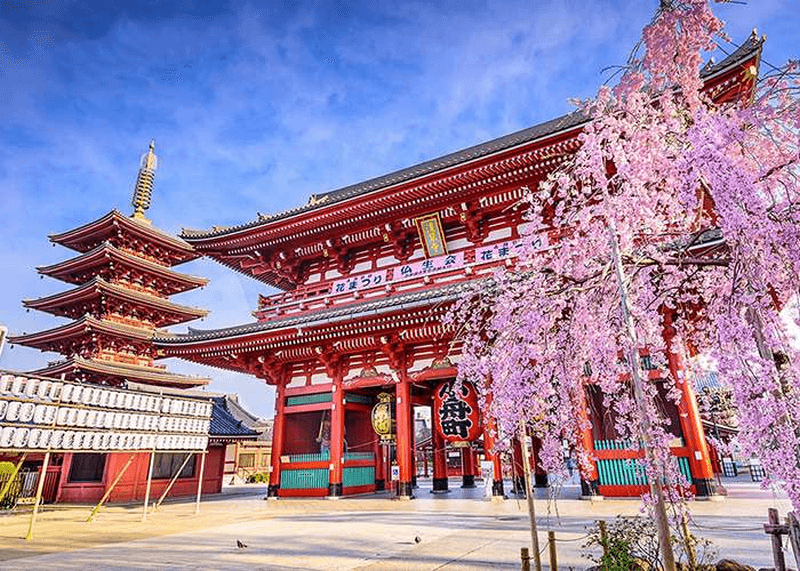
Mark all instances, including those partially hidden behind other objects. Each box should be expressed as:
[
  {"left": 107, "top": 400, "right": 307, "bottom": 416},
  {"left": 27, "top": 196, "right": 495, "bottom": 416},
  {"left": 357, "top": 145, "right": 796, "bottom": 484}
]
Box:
[{"left": 30, "top": 356, "right": 209, "bottom": 388}]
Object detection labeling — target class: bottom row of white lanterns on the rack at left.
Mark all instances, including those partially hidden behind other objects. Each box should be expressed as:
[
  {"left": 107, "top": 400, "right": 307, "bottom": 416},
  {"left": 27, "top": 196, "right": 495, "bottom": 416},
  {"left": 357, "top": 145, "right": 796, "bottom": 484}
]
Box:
[{"left": 0, "top": 426, "right": 208, "bottom": 451}]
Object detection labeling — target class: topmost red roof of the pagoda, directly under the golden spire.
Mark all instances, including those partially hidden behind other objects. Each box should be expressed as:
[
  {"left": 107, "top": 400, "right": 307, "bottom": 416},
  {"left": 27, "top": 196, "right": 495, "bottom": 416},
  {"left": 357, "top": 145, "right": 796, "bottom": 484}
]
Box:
[{"left": 49, "top": 209, "right": 200, "bottom": 265}]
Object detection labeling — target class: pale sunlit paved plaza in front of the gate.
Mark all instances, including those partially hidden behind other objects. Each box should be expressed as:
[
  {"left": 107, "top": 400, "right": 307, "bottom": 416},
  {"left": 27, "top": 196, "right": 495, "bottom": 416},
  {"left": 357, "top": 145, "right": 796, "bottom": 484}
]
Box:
[{"left": 0, "top": 479, "right": 794, "bottom": 571}]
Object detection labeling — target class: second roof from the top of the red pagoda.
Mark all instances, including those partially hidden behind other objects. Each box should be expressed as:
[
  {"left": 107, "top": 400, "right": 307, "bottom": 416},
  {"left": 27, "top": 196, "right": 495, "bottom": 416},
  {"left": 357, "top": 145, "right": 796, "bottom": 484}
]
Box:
[{"left": 36, "top": 241, "right": 208, "bottom": 295}]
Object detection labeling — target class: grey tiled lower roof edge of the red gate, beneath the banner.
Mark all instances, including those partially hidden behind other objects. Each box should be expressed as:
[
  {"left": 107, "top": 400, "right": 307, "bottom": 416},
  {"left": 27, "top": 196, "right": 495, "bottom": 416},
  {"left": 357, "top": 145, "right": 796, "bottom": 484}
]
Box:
[{"left": 153, "top": 278, "right": 484, "bottom": 347}]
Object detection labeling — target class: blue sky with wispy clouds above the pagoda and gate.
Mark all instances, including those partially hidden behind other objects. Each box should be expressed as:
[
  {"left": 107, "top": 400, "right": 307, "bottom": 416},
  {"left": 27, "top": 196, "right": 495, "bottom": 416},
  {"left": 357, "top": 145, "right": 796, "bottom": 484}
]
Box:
[{"left": 0, "top": 0, "right": 800, "bottom": 417}]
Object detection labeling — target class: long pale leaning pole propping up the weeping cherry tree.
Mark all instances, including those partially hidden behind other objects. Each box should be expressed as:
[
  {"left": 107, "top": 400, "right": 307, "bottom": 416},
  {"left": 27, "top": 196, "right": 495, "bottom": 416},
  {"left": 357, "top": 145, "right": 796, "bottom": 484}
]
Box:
[{"left": 608, "top": 230, "right": 676, "bottom": 571}]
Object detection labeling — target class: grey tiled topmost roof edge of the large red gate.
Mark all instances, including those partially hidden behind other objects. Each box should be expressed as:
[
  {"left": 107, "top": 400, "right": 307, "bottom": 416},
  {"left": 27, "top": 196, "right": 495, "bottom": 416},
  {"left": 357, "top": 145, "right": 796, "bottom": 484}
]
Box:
[{"left": 180, "top": 33, "right": 763, "bottom": 245}]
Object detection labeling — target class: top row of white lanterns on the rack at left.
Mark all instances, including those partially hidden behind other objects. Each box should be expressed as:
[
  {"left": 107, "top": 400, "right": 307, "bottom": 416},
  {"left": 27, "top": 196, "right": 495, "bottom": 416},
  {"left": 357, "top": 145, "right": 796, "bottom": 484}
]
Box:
[{"left": 0, "top": 375, "right": 212, "bottom": 418}]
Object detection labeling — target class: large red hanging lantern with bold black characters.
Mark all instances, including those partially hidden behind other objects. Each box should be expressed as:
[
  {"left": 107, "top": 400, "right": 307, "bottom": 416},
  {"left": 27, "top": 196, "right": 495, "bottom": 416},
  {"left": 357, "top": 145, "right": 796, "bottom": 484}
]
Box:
[{"left": 433, "top": 379, "right": 481, "bottom": 446}]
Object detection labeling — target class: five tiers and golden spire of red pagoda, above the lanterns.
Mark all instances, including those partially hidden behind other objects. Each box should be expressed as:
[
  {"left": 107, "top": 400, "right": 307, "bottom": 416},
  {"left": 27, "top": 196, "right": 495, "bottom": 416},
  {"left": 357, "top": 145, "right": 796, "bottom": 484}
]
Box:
[{"left": 9, "top": 141, "right": 208, "bottom": 388}]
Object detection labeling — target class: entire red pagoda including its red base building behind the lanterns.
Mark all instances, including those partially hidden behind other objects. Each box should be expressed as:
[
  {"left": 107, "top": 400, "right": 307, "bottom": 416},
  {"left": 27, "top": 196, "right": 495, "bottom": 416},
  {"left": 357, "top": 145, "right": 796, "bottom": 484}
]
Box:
[{"left": 9, "top": 142, "right": 257, "bottom": 502}]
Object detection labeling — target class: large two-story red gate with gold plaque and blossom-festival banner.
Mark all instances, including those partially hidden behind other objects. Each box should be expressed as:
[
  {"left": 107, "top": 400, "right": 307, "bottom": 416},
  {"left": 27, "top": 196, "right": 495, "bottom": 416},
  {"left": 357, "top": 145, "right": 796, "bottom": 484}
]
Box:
[{"left": 156, "top": 37, "right": 761, "bottom": 497}]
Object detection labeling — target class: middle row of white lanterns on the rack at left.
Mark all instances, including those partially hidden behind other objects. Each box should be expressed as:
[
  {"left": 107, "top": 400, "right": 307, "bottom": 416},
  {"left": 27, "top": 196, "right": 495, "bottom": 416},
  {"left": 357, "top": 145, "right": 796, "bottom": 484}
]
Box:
[{"left": 0, "top": 400, "right": 211, "bottom": 434}]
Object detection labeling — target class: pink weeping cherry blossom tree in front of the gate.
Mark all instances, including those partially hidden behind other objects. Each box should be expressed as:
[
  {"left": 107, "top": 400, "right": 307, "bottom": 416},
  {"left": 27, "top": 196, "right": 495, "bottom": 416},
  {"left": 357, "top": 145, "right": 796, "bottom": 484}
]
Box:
[{"left": 451, "top": 0, "right": 800, "bottom": 568}]
